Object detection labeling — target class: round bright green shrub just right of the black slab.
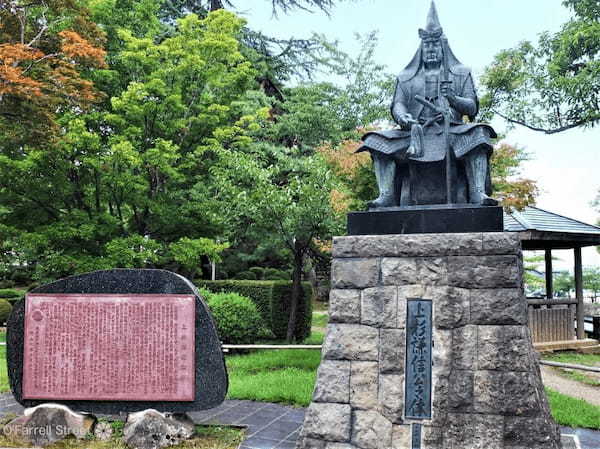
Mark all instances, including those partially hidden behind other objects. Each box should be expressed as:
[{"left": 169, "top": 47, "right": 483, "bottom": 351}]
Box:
[{"left": 206, "top": 293, "right": 264, "bottom": 345}]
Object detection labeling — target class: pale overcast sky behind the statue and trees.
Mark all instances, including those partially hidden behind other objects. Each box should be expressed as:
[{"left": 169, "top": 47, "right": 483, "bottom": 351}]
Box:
[{"left": 241, "top": 0, "right": 600, "bottom": 269}]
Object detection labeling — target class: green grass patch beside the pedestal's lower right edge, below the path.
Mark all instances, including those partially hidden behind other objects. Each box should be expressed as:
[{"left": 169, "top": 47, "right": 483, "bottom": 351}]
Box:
[{"left": 546, "top": 388, "right": 600, "bottom": 429}]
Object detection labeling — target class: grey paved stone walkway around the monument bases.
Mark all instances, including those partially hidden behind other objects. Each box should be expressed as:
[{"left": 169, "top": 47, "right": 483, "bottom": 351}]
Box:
[{"left": 0, "top": 393, "right": 600, "bottom": 449}]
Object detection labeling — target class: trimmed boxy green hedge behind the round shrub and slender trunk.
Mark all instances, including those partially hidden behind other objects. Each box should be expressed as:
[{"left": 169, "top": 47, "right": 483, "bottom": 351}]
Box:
[{"left": 196, "top": 280, "right": 313, "bottom": 341}]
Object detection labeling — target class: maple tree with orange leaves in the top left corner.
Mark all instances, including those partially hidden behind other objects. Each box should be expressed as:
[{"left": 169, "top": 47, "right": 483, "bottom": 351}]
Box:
[{"left": 0, "top": 0, "right": 105, "bottom": 150}]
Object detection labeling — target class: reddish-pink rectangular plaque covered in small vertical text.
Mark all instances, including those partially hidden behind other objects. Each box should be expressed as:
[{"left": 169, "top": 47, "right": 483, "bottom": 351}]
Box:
[{"left": 23, "top": 294, "right": 195, "bottom": 401}]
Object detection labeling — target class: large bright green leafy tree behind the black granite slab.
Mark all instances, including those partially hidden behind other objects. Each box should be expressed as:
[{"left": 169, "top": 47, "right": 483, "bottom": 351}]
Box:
[{"left": 0, "top": 11, "right": 267, "bottom": 279}]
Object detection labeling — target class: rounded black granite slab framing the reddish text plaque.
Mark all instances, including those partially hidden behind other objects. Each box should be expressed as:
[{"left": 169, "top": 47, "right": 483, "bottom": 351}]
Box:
[{"left": 6, "top": 269, "right": 229, "bottom": 415}]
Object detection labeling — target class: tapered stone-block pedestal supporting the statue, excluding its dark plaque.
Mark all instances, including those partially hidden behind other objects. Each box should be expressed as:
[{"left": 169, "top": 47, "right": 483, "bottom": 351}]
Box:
[{"left": 298, "top": 233, "right": 561, "bottom": 449}]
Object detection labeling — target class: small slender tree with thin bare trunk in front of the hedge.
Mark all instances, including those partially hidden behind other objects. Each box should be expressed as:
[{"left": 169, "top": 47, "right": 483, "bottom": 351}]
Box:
[{"left": 213, "top": 144, "right": 343, "bottom": 341}]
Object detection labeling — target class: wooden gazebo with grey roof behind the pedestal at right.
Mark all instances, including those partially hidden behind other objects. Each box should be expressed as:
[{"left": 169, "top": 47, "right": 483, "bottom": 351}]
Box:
[{"left": 504, "top": 207, "right": 600, "bottom": 339}]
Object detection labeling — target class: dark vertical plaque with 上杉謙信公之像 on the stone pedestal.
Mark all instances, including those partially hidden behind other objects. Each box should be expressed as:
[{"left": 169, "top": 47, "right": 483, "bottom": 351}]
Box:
[{"left": 404, "top": 299, "right": 432, "bottom": 419}]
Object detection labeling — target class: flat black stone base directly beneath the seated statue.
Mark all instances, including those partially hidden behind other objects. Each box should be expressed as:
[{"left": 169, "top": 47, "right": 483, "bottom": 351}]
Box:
[{"left": 348, "top": 204, "right": 504, "bottom": 235}]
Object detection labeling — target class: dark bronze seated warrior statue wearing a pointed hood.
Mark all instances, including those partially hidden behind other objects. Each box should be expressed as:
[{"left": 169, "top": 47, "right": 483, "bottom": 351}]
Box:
[{"left": 358, "top": 1, "right": 498, "bottom": 208}]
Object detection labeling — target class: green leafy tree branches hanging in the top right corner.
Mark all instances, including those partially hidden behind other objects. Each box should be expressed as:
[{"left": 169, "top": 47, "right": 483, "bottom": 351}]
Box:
[{"left": 481, "top": 0, "right": 600, "bottom": 134}]
